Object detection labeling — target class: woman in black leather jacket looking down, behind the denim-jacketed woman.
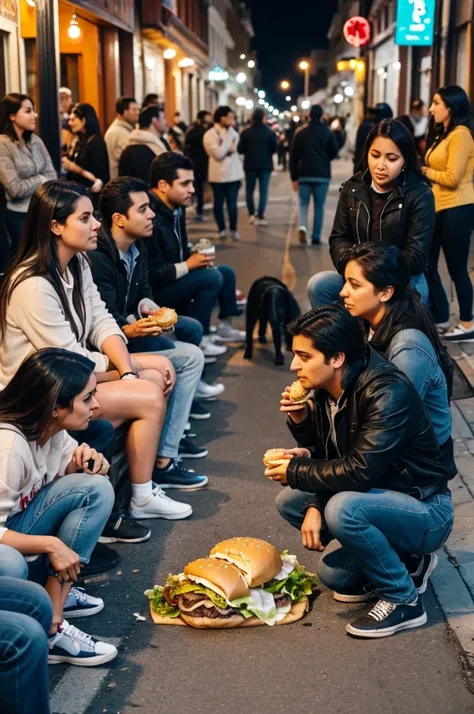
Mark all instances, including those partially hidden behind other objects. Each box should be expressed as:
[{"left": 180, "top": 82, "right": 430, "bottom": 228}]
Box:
[{"left": 308, "top": 119, "right": 435, "bottom": 307}]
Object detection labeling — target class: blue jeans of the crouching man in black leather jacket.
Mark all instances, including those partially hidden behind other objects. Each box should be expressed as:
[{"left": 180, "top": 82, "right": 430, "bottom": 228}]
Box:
[{"left": 276, "top": 487, "right": 454, "bottom": 604}]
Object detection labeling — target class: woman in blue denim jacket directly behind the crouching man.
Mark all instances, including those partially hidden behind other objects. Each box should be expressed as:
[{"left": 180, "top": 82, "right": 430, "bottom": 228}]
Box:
[{"left": 340, "top": 242, "right": 453, "bottom": 465}]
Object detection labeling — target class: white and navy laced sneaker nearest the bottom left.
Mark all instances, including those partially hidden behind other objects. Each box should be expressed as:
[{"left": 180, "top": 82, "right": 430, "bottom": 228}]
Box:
[{"left": 48, "top": 620, "right": 118, "bottom": 667}]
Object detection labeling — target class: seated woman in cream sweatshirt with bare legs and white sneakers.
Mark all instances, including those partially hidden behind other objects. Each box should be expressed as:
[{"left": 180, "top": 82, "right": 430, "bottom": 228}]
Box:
[{"left": 0, "top": 181, "right": 192, "bottom": 543}]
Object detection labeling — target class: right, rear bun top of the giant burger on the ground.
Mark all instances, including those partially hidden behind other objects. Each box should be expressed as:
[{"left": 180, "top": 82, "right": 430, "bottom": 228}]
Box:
[{"left": 210, "top": 537, "right": 282, "bottom": 584}]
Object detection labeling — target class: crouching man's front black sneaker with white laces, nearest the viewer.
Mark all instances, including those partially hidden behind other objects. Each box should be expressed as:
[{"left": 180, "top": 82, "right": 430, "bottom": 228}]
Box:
[{"left": 346, "top": 597, "right": 427, "bottom": 638}]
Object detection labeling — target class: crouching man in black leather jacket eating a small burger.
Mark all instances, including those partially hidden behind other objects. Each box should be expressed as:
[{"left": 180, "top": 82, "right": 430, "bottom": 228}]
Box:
[{"left": 265, "top": 305, "right": 456, "bottom": 637}]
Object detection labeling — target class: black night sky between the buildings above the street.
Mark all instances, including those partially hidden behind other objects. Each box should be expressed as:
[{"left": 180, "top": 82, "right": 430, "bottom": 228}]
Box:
[{"left": 247, "top": 0, "right": 337, "bottom": 110}]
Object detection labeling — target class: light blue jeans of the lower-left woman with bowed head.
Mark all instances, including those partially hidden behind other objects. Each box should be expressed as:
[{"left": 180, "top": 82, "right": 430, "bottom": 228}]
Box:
[{"left": 6, "top": 474, "right": 114, "bottom": 584}]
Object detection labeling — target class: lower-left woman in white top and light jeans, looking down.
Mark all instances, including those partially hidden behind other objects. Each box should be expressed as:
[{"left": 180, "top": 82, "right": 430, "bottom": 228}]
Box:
[{"left": 0, "top": 349, "right": 117, "bottom": 666}]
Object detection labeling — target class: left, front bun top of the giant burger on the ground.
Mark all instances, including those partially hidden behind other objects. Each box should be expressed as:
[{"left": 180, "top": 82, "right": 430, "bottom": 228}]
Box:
[{"left": 184, "top": 558, "right": 250, "bottom": 601}]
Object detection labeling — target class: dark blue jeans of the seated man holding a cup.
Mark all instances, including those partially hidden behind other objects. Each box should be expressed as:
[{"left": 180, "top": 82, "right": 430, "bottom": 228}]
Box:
[{"left": 154, "top": 265, "right": 240, "bottom": 335}]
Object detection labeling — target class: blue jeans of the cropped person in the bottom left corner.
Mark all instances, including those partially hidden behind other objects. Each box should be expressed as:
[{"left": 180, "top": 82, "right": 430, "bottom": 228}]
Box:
[{"left": 0, "top": 572, "right": 53, "bottom": 714}]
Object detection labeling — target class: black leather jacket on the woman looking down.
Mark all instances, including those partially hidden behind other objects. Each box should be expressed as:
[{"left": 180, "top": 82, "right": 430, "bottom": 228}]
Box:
[{"left": 329, "top": 171, "right": 435, "bottom": 275}]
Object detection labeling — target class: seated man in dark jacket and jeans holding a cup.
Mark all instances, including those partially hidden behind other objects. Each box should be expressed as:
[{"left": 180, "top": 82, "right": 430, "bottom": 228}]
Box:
[{"left": 148, "top": 151, "right": 245, "bottom": 357}]
